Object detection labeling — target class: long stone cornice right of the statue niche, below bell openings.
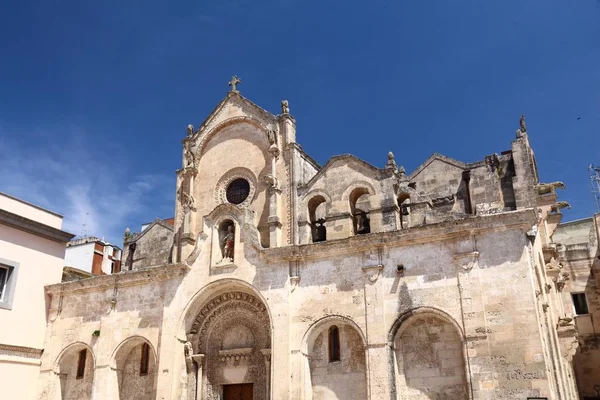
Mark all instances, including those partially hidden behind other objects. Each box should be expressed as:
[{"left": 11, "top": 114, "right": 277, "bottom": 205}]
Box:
[{"left": 261, "top": 209, "right": 537, "bottom": 261}]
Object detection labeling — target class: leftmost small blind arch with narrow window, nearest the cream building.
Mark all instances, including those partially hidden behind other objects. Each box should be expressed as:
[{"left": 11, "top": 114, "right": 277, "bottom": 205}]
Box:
[{"left": 57, "top": 343, "right": 95, "bottom": 400}]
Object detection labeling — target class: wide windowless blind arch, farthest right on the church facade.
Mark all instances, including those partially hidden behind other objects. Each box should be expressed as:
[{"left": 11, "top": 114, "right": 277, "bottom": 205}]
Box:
[{"left": 391, "top": 309, "right": 469, "bottom": 400}]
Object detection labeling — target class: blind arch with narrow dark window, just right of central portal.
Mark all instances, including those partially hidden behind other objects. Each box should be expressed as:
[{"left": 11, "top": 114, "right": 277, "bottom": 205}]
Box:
[{"left": 301, "top": 315, "right": 369, "bottom": 399}]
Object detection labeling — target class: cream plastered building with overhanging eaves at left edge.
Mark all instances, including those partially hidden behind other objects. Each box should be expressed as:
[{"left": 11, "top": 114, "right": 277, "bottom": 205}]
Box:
[{"left": 0, "top": 193, "right": 73, "bottom": 400}]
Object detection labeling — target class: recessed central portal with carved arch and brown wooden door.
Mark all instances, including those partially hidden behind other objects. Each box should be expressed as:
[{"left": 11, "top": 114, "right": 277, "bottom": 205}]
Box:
[{"left": 186, "top": 290, "right": 271, "bottom": 400}]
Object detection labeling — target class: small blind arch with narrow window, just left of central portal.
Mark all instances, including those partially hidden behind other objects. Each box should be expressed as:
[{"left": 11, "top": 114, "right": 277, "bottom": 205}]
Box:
[{"left": 113, "top": 336, "right": 157, "bottom": 400}]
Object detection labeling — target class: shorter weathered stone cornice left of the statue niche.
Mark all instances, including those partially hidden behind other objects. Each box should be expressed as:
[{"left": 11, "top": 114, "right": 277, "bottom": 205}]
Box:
[{"left": 46, "top": 264, "right": 190, "bottom": 295}]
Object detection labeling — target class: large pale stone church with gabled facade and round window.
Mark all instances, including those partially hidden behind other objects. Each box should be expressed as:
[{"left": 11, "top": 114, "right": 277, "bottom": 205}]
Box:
[{"left": 39, "top": 77, "right": 578, "bottom": 400}]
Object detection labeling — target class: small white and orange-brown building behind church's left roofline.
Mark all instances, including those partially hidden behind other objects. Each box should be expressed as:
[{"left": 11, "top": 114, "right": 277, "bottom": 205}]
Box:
[{"left": 65, "top": 236, "right": 121, "bottom": 280}]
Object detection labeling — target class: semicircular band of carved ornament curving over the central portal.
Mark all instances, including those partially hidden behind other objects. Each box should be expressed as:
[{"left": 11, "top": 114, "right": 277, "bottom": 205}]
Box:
[{"left": 190, "top": 292, "right": 270, "bottom": 352}]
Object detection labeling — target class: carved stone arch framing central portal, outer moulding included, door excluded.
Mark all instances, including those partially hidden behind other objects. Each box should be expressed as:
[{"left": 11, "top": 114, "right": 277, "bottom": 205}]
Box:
[{"left": 182, "top": 279, "right": 272, "bottom": 399}]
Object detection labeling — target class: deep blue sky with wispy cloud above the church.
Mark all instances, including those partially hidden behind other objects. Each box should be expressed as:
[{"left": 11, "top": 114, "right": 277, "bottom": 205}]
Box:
[{"left": 0, "top": 0, "right": 600, "bottom": 243}]
